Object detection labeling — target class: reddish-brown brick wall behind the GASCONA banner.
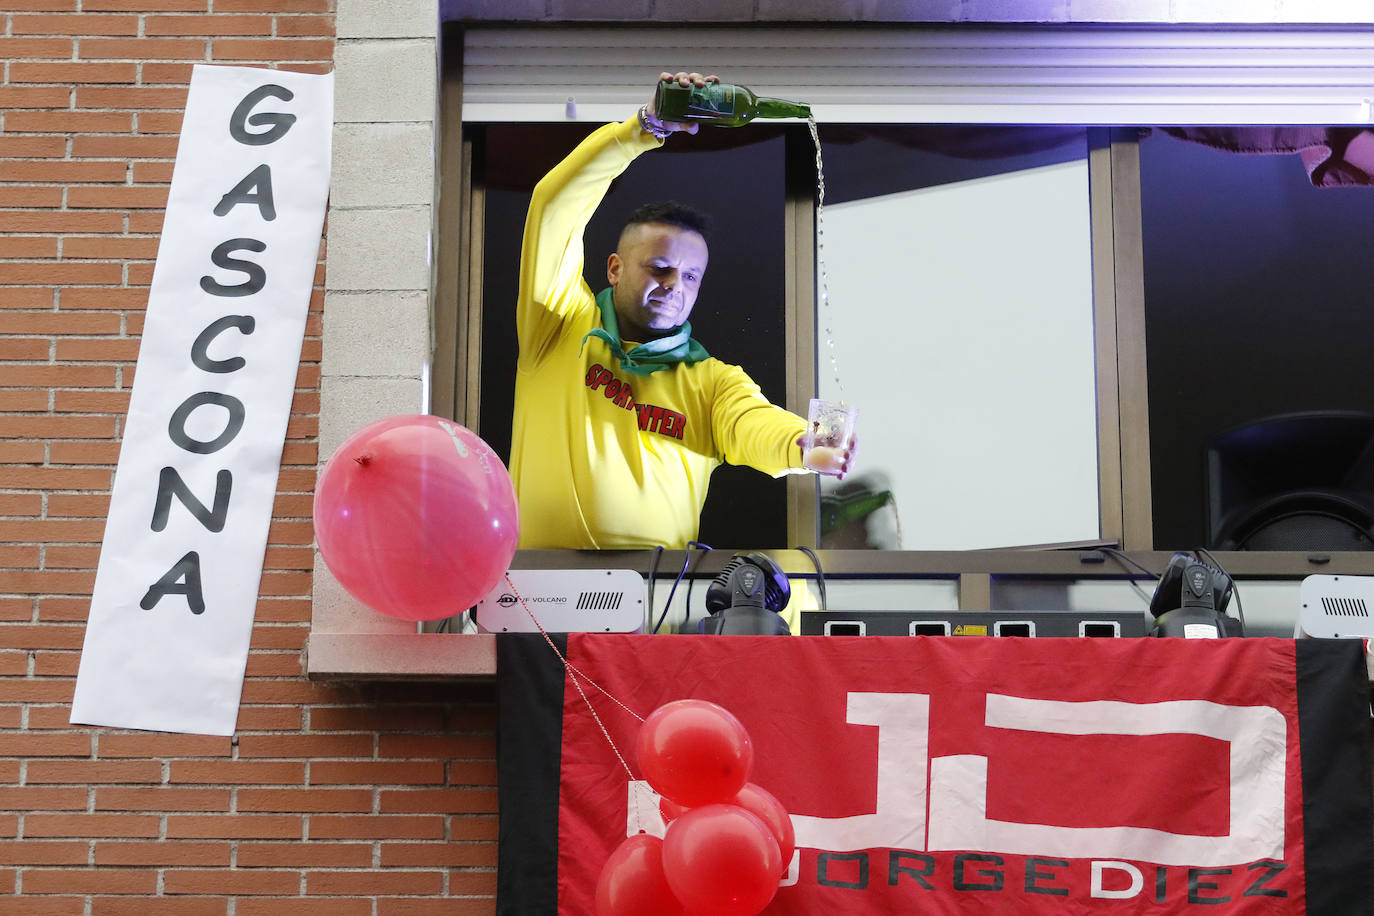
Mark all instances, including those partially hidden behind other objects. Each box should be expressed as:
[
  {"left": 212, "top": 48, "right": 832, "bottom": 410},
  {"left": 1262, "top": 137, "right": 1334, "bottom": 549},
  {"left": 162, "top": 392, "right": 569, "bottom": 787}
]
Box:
[{"left": 0, "top": 0, "right": 496, "bottom": 916}]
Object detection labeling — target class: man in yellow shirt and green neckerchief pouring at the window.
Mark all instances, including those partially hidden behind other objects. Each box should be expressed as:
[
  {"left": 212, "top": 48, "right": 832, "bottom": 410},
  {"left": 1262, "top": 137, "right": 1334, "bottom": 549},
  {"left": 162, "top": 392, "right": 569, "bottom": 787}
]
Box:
[{"left": 510, "top": 73, "right": 851, "bottom": 549}]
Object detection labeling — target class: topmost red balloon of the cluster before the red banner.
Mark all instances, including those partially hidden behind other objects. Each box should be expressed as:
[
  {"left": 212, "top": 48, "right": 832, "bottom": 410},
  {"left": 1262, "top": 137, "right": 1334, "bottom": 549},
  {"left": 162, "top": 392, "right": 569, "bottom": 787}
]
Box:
[{"left": 636, "top": 699, "right": 754, "bottom": 808}]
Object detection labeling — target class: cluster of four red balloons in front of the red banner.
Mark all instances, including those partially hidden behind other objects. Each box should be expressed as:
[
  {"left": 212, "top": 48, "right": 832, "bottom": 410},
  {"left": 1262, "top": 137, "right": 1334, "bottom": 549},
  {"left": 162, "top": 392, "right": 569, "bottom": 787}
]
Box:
[{"left": 596, "top": 699, "right": 796, "bottom": 916}]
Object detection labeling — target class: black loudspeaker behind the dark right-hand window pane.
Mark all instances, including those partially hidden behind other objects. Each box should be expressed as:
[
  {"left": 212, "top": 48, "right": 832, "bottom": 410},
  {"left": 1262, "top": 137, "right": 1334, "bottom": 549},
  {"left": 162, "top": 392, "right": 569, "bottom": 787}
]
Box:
[{"left": 1206, "top": 411, "right": 1374, "bottom": 551}]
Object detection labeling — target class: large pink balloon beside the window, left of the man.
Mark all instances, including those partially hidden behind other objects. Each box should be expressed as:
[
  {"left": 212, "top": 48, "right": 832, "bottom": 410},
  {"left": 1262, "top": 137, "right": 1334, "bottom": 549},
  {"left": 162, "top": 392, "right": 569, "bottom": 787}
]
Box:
[{"left": 315, "top": 415, "right": 519, "bottom": 621}]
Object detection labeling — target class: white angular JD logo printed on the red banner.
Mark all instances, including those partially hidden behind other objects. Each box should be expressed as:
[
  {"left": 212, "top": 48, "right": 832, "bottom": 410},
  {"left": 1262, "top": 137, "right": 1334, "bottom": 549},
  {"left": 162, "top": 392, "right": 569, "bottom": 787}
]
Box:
[{"left": 629, "top": 694, "right": 1287, "bottom": 878}]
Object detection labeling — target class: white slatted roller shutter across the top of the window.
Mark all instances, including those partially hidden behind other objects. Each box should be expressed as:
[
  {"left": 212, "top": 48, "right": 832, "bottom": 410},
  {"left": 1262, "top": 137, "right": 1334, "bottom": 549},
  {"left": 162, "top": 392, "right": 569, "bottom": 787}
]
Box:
[{"left": 463, "top": 25, "right": 1374, "bottom": 125}]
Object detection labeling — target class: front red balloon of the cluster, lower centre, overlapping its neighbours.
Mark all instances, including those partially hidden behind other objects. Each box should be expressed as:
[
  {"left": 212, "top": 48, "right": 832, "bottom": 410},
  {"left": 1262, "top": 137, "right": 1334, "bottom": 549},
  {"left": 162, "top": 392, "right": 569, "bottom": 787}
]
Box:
[{"left": 664, "top": 805, "right": 782, "bottom": 916}]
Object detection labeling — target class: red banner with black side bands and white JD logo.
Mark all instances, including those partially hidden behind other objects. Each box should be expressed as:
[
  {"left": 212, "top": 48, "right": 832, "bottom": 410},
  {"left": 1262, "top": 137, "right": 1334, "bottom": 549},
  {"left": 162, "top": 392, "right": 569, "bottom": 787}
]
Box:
[{"left": 499, "top": 634, "right": 1374, "bottom": 915}]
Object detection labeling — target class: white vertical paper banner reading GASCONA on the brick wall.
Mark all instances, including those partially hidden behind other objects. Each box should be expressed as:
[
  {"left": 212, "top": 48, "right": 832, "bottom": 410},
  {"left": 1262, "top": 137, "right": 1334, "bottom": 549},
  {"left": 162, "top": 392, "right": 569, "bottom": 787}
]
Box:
[{"left": 71, "top": 65, "right": 334, "bottom": 735}]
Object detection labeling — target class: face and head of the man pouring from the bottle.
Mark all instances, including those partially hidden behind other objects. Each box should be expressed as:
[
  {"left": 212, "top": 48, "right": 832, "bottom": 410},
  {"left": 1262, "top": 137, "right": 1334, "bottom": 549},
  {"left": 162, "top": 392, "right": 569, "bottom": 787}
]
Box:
[{"left": 606, "top": 222, "right": 706, "bottom": 341}]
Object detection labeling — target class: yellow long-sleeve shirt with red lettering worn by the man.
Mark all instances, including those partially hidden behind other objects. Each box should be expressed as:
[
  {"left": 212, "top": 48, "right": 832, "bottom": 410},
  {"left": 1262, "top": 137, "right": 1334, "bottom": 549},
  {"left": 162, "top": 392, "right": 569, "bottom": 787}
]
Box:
[{"left": 510, "top": 118, "right": 807, "bottom": 549}]
